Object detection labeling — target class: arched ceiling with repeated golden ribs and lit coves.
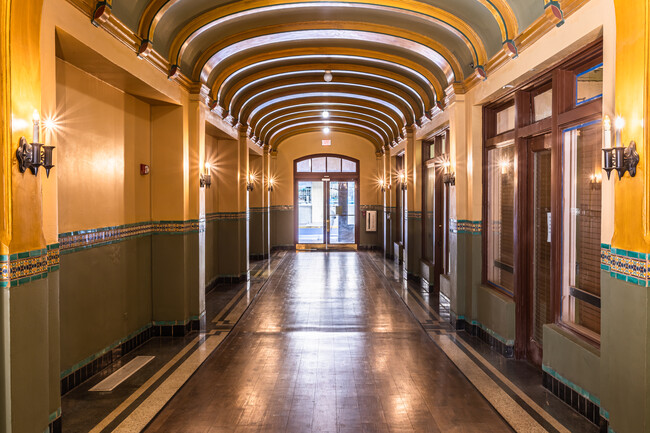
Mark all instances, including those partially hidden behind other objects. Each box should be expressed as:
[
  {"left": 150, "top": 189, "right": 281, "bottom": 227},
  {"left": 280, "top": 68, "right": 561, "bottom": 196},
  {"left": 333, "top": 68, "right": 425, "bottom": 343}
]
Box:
[{"left": 112, "top": 0, "right": 545, "bottom": 148}]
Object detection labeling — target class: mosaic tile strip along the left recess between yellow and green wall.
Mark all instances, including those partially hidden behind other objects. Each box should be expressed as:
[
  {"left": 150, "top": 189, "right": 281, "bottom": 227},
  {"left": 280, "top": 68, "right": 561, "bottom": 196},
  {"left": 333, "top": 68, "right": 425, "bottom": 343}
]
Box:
[{"left": 59, "top": 220, "right": 205, "bottom": 254}]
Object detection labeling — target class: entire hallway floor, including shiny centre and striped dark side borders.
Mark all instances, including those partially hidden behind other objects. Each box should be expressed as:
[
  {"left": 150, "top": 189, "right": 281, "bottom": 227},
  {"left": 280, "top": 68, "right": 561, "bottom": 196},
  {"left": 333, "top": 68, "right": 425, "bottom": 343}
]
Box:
[{"left": 63, "top": 252, "right": 597, "bottom": 433}]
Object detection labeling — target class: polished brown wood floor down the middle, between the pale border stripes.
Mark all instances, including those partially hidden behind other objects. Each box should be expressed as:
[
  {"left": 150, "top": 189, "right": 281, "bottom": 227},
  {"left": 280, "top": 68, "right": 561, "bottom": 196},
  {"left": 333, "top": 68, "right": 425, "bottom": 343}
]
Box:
[{"left": 146, "top": 252, "right": 511, "bottom": 433}]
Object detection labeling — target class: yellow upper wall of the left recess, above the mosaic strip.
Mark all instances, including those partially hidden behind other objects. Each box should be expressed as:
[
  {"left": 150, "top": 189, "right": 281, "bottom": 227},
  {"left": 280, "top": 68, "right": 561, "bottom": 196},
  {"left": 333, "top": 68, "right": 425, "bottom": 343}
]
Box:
[{"left": 57, "top": 60, "right": 151, "bottom": 233}]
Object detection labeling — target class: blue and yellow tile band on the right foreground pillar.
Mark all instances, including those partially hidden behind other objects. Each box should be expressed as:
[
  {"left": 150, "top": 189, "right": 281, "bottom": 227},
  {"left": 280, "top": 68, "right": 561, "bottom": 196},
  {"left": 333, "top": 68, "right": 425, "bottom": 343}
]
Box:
[{"left": 600, "top": 244, "right": 650, "bottom": 287}]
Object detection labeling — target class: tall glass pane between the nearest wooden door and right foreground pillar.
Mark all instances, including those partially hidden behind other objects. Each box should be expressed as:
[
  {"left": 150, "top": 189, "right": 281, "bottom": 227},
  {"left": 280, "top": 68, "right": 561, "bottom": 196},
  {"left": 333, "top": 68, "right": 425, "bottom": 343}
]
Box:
[{"left": 562, "top": 122, "right": 602, "bottom": 333}]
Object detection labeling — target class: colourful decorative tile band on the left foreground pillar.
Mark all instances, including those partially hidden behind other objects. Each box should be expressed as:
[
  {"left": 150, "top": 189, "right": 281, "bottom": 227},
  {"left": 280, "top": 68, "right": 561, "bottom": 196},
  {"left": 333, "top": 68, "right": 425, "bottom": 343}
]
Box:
[{"left": 0, "top": 244, "right": 59, "bottom": 287}]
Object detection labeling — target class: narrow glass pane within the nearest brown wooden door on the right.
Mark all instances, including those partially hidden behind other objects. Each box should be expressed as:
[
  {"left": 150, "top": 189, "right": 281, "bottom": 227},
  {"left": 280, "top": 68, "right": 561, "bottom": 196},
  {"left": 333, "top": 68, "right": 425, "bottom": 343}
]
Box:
[{"left": 533, "top": 147, "right": 551, "bottom": 344}]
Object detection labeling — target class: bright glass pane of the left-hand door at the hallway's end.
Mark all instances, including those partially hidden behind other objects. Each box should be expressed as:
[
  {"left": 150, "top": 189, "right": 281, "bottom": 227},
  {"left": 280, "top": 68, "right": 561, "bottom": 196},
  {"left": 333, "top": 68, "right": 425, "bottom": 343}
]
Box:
[{"left": 298, "top": 181, "right": 325, "bottom": 244}]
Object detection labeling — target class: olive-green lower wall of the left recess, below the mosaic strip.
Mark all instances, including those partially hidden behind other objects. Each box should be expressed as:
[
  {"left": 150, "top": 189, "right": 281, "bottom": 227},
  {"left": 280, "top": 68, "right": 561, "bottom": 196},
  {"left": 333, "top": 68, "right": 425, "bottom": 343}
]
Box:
[{"left": 59, "top": 236, "right": 152, "bottom": 371}]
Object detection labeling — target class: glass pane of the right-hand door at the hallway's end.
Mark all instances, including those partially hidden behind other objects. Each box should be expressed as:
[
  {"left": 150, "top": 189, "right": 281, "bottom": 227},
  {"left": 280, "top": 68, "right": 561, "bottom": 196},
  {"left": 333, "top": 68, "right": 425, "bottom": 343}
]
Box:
[{"left": 329, "top": 182, "right": 356, "bottom": 244}]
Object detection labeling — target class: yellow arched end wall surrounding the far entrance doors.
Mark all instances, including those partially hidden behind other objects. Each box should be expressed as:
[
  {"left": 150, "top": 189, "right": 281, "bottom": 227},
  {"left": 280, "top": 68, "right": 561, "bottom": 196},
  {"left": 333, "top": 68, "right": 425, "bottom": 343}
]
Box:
[{"left": 271, "top": 132, "right": 382, "bottom": 206}]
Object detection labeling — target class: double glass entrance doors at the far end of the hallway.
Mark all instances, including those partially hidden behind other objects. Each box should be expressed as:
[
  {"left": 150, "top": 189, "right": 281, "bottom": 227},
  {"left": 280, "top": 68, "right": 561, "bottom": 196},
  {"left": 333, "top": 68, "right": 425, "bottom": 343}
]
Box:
[{"left": 298, "top": 180, "right": 357, "bottom": 248}]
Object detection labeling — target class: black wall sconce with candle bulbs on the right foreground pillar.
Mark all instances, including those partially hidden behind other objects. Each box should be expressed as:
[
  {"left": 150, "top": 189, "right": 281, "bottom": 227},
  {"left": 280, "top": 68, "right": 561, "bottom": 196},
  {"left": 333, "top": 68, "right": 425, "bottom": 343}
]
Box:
[{"left": 603, "top": 116, "right": 639, "bottom": 180}]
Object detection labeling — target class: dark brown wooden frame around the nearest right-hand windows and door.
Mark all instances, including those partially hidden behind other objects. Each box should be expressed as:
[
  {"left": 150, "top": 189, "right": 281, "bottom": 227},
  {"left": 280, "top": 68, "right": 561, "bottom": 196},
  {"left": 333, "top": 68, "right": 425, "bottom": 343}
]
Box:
[{"left": 482, "top": 39, "right": 603, "bottom": 363}]
